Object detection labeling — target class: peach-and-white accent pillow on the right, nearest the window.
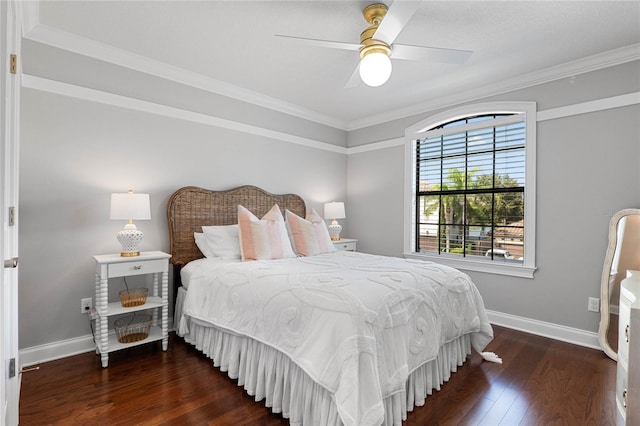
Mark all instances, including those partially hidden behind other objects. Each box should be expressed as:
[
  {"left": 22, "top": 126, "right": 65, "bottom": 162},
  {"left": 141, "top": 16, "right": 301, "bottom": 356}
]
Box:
[{"left": 285, "top": 210, "right": 337, "bottom": 256}]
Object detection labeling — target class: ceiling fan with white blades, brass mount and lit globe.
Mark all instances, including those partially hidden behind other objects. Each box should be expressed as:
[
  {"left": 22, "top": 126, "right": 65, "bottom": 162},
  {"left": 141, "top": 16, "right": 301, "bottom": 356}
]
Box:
[{"left": 276, "top": 0, "right": 473, "bottom": 87}]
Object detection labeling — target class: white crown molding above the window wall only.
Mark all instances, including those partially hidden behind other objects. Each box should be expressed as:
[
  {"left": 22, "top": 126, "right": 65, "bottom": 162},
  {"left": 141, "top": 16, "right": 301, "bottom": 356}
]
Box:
[{"left": 346, "top": 43, "right": 640, "bottom": 131}]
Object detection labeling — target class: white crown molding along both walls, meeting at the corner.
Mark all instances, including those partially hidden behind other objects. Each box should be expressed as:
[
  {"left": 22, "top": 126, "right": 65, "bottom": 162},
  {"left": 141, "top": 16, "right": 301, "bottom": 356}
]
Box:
[{"left": 24, "top": 13, "right": 640, "bottom": 131}]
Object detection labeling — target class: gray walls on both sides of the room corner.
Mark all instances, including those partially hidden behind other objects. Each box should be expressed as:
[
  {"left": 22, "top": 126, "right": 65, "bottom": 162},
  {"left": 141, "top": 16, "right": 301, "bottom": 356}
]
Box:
[{"left": 19, "top": 56, "right": 640, "bottom": 349}]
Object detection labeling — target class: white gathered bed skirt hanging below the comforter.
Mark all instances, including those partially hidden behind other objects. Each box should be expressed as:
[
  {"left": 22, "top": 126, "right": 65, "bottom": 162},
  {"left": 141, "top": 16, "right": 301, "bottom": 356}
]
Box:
[{"left": 174, "top": 288, "right": 471, "bottom": 426}]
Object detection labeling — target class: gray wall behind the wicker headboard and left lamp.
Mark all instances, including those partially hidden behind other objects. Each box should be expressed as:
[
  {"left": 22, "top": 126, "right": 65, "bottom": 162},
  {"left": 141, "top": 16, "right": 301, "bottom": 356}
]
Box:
[{"left": 19, "top": 89, "right": 347, "bottom": 349}]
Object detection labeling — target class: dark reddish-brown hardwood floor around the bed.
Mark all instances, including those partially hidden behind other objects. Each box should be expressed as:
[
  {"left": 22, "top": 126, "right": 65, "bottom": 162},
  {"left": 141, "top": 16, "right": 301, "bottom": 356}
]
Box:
[{"left": 20, "top": 327, "right": 616, "bottom": 426}]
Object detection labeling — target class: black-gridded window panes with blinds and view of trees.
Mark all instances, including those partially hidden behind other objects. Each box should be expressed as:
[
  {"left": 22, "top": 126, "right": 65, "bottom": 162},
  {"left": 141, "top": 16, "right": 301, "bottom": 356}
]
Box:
[{"left": 413, "top": 114, "right": 526, "bottom": 264}]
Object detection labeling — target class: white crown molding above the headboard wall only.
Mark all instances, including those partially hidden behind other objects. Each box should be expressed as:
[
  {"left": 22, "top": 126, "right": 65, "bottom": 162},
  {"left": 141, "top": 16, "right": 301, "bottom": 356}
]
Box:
[{"left": 24, "top": 24, "right": 347, "bottom": 130}]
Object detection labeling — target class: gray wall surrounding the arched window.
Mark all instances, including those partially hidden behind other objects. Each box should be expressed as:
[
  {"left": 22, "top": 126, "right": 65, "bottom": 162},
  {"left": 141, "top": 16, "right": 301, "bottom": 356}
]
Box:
[{"left": 347, "top": 62, "right": 640, "bottom": 332}]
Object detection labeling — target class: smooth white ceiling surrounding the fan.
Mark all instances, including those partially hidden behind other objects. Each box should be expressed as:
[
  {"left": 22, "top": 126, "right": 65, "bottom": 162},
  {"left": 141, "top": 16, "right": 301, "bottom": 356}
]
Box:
[{"left": 26, "top": 0, "right": 640, "bottom": 129}]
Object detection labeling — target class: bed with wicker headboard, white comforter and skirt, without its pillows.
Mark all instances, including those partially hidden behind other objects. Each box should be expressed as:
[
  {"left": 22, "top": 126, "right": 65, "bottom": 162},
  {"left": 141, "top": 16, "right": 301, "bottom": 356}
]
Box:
[{"left": 167, "top": 186, "right": 493, "bottom": 426}]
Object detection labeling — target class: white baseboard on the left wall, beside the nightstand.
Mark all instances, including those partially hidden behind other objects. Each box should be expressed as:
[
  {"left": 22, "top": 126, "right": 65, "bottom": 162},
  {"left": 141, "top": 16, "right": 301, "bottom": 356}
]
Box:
[{"left": 20, "top": 318, "right": 173, "bottom": 367}]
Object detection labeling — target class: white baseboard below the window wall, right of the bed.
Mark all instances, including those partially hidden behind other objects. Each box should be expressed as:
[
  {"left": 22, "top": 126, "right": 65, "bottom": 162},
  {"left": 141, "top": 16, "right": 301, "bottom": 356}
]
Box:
[{"left": 487, "top": 310, "right": 601, "bottom": 349}]
